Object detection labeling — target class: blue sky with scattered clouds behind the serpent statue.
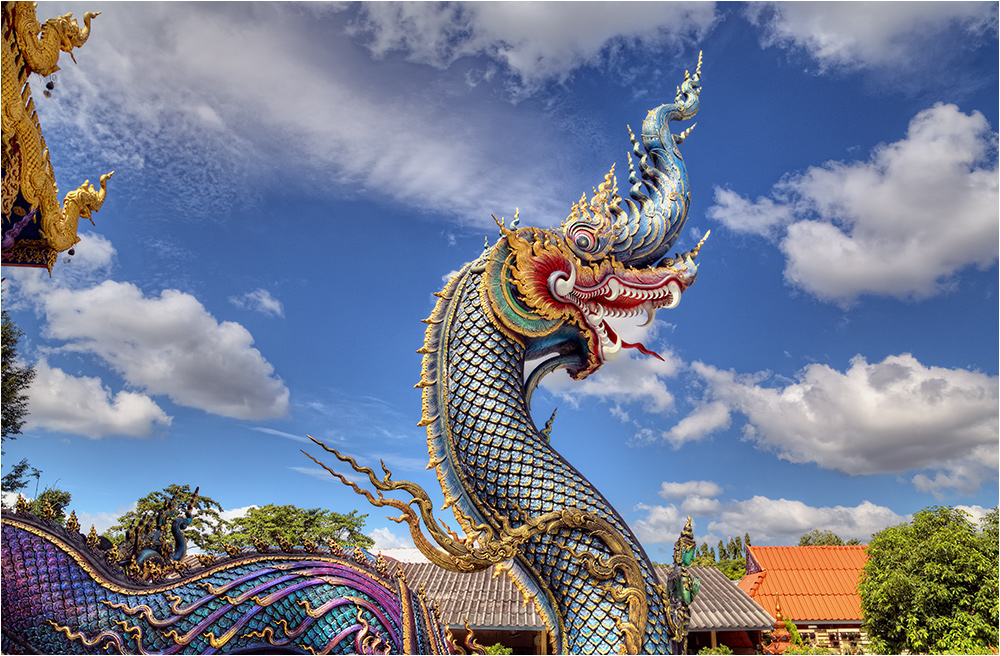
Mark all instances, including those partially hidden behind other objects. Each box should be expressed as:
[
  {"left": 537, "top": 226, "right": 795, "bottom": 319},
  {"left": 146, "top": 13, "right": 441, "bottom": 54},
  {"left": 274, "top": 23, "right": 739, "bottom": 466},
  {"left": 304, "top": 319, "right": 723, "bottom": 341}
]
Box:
[{"left": 3, "top": 2, "right": 1000, "bottom": 560}]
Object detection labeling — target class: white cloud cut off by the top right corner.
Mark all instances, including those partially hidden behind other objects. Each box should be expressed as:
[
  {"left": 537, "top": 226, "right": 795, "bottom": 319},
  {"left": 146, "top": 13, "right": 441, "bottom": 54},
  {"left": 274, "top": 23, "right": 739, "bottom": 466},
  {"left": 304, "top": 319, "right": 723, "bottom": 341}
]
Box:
[{"left": 746, "top": 2, "right": 997, "bottom": 69}]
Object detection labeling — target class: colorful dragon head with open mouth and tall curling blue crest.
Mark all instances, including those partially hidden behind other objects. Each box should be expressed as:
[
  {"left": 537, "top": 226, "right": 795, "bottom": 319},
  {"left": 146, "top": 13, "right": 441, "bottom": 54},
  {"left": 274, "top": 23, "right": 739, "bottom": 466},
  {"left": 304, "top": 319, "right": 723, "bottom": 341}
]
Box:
[{"left": 483, "top": 56, "right": 708, "bottom": 379}]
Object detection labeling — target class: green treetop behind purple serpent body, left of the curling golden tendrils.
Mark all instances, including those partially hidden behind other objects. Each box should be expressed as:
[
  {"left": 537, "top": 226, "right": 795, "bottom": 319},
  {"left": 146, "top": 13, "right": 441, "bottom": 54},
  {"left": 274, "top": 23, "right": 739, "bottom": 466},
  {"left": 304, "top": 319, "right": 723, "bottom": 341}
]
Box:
[{"left": 206, "top": 504, "right": 375, "bottom": 551}]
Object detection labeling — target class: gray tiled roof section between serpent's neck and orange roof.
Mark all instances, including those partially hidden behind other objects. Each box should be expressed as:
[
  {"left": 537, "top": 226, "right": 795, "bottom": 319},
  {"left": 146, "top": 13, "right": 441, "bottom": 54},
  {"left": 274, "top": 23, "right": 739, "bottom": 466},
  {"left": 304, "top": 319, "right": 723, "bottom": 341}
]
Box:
[{"left": 656, "top": 567, "right": 774, "bottom": 631}]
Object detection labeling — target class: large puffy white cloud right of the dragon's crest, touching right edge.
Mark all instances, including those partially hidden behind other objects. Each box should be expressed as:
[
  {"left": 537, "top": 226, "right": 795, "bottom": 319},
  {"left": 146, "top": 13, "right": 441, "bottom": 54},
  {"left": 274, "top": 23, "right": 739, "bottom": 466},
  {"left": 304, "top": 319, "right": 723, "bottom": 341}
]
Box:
[{"left": 709, "top": 103, "right": 1000, "bottom": 305}]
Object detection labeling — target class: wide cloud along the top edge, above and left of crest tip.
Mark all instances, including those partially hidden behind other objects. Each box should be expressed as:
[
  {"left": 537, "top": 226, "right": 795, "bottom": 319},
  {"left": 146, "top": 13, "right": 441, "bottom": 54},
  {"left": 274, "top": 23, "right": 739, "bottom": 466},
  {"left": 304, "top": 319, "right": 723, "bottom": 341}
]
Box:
[{"left": 354, "top": 2, "right": 716, "bottom": 93}]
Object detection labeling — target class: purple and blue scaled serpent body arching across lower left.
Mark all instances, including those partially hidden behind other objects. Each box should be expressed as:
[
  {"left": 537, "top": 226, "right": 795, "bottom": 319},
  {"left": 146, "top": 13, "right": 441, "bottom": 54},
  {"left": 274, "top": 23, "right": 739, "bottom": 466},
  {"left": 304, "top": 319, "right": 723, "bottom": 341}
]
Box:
[{"left": 0, "top": 513, "right": 447, "bottom": 654}]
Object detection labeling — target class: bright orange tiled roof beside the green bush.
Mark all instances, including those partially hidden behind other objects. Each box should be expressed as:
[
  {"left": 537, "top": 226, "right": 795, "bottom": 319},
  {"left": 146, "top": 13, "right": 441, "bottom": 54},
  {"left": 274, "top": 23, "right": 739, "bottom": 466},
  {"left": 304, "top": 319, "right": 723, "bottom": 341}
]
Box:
[{"left": 739, "top": 545, "right": 868, "bottom": 623}]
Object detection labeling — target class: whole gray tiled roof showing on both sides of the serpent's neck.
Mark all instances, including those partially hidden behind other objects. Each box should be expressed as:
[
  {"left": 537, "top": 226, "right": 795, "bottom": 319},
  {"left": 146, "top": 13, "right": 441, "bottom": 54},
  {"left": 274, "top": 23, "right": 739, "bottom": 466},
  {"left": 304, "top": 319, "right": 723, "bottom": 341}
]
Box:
[{"left": 390, "top": 562, "right": 774, "bottom": 631}]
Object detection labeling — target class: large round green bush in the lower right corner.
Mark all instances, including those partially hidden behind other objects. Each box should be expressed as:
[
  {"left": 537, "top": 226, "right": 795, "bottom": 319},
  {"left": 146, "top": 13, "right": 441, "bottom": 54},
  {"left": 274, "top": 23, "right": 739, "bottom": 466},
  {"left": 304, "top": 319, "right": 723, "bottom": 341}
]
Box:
[{"left": 858, "top": 506, "right": 1000, "bottom": 653}]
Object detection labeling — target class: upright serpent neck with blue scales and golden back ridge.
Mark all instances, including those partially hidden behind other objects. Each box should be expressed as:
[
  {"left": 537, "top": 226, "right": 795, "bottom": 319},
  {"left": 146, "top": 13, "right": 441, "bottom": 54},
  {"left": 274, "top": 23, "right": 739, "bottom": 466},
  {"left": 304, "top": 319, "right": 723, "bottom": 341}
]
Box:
[{"left": 429, "top": 266, "right": 670, "bottom": 653}]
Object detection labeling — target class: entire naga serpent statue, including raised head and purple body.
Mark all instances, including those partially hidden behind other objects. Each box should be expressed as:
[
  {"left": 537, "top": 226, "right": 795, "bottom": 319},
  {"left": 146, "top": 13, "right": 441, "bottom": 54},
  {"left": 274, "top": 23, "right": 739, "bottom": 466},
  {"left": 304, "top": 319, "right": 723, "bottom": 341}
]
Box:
[{"left": 2, "top": 57, "right": 707, "bottom": 654}]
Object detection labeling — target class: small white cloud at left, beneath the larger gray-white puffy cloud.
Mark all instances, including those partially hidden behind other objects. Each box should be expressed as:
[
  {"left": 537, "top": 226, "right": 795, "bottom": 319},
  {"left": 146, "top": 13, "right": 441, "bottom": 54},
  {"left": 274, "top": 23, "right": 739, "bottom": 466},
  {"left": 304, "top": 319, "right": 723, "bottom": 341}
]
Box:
[{"left": 26, "top": 358, "right": 171, "bottom": 439}]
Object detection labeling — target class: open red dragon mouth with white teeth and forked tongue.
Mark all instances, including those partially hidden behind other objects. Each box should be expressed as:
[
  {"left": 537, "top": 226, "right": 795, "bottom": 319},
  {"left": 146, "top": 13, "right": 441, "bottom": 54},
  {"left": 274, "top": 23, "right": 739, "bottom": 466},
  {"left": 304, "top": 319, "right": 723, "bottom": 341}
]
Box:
[{"left": 548, "top": 258, "right": 697, "bottom": 362}]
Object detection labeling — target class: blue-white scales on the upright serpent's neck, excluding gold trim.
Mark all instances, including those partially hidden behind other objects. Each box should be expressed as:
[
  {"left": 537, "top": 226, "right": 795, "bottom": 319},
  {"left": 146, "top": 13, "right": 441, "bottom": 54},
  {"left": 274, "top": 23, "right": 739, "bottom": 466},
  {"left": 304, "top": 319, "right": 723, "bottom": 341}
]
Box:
[{"left": 445, "top": 273, "right": 670, "bottom": 653}]
